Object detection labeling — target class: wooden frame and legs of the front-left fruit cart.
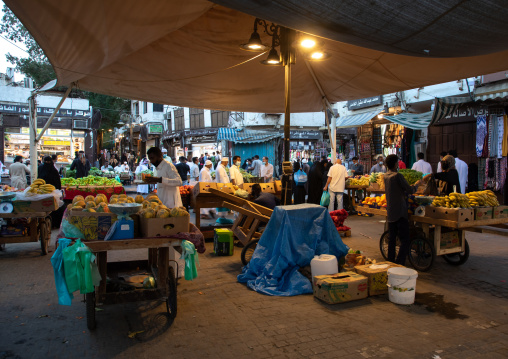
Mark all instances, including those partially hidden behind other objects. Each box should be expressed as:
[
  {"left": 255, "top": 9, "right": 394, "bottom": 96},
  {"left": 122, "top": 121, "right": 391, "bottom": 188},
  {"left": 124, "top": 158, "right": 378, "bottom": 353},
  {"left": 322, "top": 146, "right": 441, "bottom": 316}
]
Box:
[{"left": 85, "top": 237, "right": 181, "bottom": 330}]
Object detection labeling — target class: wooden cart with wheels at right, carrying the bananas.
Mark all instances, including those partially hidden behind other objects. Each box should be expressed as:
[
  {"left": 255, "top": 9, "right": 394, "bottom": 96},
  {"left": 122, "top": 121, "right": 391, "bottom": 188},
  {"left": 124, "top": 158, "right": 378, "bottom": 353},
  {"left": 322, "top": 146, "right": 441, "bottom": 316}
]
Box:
[{"left": 358, "top": 207, "right": 508, "bottom": 271}]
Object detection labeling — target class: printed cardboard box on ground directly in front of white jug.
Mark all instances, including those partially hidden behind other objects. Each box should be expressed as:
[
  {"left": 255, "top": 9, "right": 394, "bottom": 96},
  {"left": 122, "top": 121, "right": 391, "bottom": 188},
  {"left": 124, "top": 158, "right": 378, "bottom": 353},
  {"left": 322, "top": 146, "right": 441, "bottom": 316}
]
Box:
[{"left": 312, "top": 272, "right": 368, "bottom": 304}]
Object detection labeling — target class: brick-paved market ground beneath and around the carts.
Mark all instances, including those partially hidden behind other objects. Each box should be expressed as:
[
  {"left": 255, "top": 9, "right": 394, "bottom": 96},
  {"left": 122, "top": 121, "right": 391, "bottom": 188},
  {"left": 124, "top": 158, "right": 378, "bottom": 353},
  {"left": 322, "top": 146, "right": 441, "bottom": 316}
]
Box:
[{"left": 0, "top": 211, "right": 508, "bottom": 359}]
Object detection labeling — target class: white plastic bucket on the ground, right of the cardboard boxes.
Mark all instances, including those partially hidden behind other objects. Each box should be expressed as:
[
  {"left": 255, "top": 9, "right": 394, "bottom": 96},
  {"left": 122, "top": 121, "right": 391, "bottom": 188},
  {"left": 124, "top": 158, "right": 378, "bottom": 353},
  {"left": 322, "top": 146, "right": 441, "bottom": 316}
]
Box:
[{"left": 388, "top": 267, "right": 418, "bottom": 305}]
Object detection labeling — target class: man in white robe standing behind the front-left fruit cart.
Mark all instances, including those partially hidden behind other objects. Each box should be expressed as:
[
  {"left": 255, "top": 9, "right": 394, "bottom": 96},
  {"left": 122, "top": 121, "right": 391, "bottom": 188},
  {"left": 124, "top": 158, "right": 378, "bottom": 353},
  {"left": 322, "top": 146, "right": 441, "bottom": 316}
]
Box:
[{"left": 145, "top": 147, "right": 182, "bottom": 208}]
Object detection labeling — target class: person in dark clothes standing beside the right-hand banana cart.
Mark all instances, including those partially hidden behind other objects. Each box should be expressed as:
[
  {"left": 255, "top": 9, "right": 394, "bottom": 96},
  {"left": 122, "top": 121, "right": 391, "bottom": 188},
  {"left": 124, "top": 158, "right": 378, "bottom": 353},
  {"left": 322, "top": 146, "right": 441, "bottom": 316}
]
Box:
[{"left": 384, "top": 155, "right": 421, "bottom": 265}]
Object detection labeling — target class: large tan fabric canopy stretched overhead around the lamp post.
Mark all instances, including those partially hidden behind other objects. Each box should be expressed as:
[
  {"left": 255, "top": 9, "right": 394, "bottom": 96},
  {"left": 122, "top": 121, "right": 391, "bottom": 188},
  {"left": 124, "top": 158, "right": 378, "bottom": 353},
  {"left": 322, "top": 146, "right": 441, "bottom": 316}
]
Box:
[{"left": 5, "top": 0, "right": 508, "bottom": 113}]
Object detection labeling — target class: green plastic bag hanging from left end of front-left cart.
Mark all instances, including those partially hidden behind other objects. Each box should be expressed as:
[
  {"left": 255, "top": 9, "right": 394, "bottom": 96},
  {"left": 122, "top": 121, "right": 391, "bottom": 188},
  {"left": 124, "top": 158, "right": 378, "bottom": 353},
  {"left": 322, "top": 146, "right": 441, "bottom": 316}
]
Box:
[{"left": 63, "top": 239, "right": 101, "bottom": 294}]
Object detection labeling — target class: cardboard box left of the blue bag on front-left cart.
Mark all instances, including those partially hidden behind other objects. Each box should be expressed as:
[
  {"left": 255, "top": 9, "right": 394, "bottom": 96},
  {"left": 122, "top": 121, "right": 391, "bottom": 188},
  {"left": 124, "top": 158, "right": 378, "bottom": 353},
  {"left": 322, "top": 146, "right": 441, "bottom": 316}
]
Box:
[{"left": 69, "top": 210, "right": 116, "bottom": 241}]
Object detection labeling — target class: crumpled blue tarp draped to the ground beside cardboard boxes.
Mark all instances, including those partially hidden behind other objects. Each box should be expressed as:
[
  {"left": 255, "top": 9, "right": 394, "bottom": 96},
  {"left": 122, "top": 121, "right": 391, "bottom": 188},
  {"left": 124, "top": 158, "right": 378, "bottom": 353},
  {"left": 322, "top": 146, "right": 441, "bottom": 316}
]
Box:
[{"left": 238, "top": 204, "right": 349, "bottom": 296}]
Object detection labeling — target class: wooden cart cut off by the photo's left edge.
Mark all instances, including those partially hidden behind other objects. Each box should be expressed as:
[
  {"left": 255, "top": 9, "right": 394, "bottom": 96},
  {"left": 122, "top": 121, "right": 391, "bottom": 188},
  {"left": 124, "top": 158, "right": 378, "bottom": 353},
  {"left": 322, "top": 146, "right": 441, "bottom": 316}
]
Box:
[{"left": 0, "top": 212, "right": 51, "bottom": 255}]
